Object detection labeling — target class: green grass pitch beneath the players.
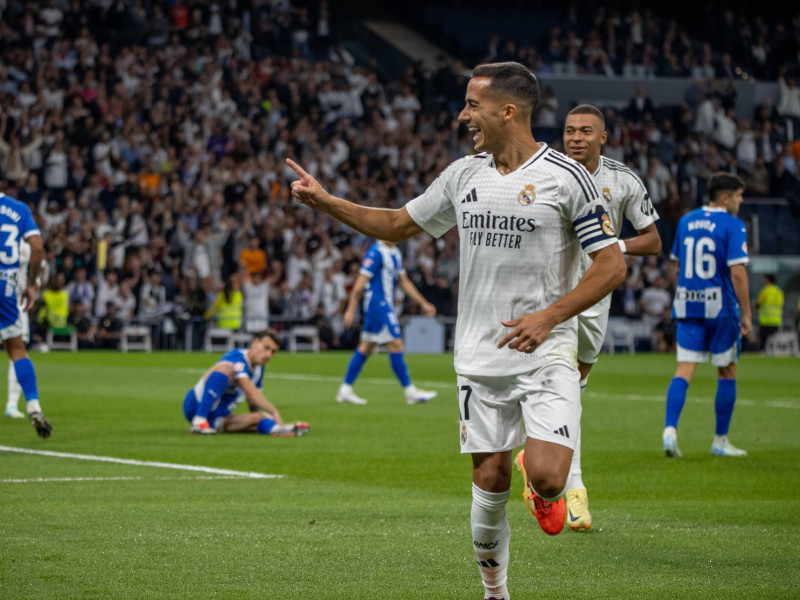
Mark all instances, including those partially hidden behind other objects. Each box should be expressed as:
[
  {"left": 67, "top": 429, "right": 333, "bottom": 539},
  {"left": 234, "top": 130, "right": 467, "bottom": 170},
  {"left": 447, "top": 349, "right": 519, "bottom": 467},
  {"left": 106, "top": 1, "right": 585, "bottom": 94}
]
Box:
[{"left": 0, "top": 352, "right": 800, "bottom": 600}]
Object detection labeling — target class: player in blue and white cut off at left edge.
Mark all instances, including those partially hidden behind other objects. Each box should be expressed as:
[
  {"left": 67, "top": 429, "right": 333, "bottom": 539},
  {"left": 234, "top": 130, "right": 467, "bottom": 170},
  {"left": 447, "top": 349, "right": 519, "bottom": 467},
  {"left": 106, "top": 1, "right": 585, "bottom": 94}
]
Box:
[{"left": 0, "top": 193, "right": 53, "bottom": 438}]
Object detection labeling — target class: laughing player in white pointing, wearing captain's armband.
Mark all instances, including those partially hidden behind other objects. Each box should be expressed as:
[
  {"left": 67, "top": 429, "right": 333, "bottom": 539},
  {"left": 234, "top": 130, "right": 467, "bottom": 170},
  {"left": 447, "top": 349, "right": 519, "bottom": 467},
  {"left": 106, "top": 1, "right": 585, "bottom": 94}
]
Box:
[{"left": 287, "top": 63, "right": 625, "bottom": 600}]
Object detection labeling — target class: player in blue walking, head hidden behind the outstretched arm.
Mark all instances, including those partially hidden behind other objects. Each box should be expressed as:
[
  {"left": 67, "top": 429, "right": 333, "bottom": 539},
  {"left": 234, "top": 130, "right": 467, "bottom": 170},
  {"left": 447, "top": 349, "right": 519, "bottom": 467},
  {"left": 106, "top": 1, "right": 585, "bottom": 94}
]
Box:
[{"left": 336, "top": 241, "right": 436, "bottom": 404}]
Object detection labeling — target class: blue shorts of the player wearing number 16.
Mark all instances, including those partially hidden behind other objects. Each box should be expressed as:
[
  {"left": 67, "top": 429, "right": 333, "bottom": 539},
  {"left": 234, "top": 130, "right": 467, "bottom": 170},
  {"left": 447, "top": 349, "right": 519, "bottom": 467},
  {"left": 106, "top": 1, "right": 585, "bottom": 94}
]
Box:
[{"left": 676, "top": 317, "right": 742, "bottom": 367}]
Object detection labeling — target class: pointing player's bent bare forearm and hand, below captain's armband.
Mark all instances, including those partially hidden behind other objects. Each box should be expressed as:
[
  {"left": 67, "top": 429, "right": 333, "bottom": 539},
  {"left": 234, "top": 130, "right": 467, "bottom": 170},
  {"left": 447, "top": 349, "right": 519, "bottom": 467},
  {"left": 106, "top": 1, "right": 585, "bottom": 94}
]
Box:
[{"left": 497, "top": 244, "right": 626, "bottom": 354}]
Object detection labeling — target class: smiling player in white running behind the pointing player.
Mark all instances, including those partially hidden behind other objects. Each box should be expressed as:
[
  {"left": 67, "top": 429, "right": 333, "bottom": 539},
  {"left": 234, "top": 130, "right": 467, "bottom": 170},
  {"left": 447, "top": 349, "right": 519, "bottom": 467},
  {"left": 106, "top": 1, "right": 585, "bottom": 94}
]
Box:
[{"left": 520, "top": 104, "right": 661, "bottom": 531}]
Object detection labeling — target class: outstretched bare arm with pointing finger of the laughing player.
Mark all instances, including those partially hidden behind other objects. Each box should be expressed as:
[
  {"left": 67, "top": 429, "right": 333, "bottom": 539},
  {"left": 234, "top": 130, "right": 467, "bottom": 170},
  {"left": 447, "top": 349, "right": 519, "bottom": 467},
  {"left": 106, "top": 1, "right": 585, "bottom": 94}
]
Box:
[{"left": 286, "top": 158, "right": 422, "bottom": 242}]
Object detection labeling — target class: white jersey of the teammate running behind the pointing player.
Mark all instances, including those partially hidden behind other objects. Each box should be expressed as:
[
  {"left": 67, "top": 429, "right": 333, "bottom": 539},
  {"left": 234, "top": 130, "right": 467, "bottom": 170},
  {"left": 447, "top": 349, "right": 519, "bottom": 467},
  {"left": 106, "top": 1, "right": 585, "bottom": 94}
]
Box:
[{"left": 580, "top": 156, "right": 658, "bottom": 316}]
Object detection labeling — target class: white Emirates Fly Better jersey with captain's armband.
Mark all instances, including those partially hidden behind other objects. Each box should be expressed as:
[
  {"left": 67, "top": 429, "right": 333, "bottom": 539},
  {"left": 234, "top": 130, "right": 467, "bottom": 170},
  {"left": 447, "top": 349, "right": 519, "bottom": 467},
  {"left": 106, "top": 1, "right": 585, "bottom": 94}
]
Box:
[{"left": 407, "top": 144, "right": 617, "bottom": 376}]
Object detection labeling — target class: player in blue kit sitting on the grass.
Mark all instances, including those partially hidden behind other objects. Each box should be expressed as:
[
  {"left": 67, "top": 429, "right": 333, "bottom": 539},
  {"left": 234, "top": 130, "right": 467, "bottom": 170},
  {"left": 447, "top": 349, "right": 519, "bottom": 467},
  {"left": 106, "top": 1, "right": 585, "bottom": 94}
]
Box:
[{"left": 183, "top": 329, "right": 309, "bottom": 436}]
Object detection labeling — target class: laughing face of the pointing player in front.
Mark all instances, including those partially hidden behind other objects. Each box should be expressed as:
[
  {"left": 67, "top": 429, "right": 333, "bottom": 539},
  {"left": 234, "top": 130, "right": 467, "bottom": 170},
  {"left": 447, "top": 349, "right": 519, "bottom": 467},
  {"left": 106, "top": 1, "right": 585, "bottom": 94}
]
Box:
[{"left": 458, "top": 77, "right": 508, "bottom": 154}]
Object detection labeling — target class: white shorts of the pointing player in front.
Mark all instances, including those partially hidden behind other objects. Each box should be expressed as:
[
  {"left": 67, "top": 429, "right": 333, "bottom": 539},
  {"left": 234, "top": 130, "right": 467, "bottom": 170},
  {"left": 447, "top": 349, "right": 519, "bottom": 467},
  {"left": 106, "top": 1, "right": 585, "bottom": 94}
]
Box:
[{"left": 457, "top": 360, "right": 581, "bottom": 454}]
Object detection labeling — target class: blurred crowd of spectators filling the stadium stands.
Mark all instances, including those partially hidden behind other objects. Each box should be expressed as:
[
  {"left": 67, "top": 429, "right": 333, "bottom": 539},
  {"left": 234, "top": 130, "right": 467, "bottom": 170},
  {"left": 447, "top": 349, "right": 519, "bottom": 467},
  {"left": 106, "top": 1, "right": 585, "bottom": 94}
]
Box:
[{"left": 0, "top": 0, "right": 800, "bottom": 348}]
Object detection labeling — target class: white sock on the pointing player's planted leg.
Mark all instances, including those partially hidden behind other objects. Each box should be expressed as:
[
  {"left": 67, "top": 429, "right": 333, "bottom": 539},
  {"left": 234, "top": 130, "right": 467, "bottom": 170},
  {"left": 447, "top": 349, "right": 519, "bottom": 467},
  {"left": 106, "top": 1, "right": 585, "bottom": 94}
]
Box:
[{"left": 470, "top": 483, "right": 511, "bottom": 600}]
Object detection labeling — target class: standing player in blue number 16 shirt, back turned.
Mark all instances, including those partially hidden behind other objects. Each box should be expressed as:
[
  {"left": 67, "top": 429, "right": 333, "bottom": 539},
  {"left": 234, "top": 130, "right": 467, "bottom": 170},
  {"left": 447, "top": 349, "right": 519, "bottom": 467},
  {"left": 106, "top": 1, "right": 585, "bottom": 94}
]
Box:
[{"left": 662, "top": 173, "right": 752, "bottom": 458}]
